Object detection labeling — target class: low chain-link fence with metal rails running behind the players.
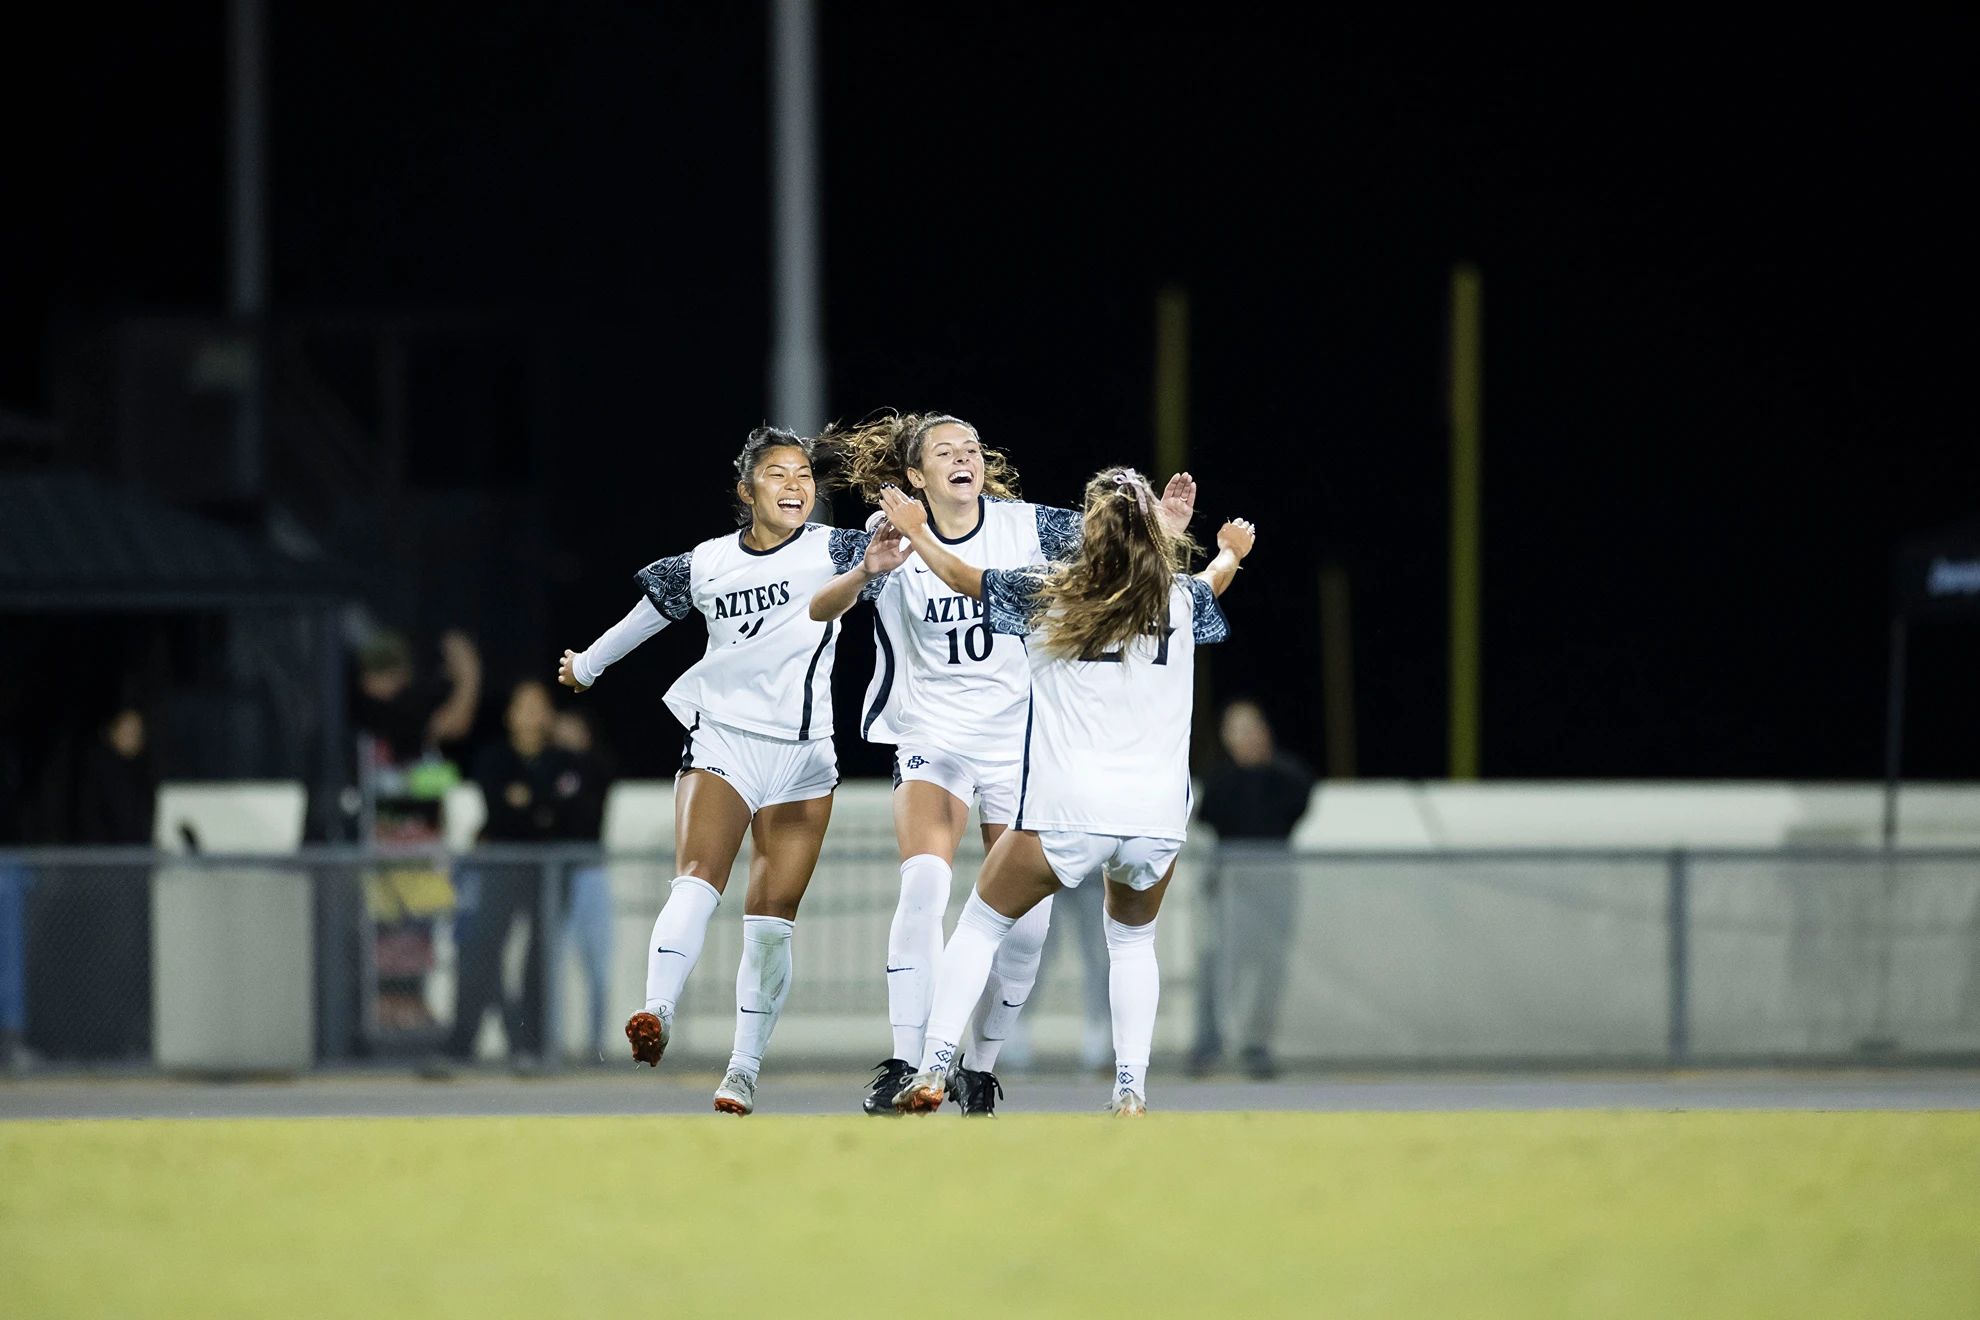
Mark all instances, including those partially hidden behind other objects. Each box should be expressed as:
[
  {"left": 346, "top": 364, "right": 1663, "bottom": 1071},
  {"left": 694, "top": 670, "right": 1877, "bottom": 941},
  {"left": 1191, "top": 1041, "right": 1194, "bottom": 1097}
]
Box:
[{"left": 0, "top": 837, "right": 1980, "bottom": 1073}]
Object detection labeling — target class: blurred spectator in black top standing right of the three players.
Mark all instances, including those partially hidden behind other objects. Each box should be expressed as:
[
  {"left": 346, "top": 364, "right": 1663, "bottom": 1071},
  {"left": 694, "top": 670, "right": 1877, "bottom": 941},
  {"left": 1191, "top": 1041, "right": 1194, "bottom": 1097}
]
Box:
[{"left": 1190, "top": 701, "right": 1313, "bottom": 1079}]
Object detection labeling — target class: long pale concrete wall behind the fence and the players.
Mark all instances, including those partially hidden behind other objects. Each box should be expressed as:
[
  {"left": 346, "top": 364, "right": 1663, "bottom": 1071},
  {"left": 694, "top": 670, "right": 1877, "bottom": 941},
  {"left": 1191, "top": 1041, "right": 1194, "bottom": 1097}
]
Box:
[{"left": 538, "top": 782, "right": 1980, "bottom": 1067}]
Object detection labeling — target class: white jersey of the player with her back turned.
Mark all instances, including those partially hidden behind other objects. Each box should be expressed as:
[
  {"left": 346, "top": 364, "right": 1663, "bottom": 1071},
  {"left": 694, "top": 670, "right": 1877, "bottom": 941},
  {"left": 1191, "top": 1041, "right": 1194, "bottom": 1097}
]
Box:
[{"left": 984, "top": 570, "right": 1228, "bottom": 839}]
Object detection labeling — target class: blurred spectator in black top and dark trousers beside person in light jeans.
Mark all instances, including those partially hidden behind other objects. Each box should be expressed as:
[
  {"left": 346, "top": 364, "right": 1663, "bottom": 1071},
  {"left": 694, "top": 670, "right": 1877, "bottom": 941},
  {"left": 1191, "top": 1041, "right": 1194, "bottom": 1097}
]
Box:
[{"left": 447, "top": 679, "right": 584, "bottom": 1063}]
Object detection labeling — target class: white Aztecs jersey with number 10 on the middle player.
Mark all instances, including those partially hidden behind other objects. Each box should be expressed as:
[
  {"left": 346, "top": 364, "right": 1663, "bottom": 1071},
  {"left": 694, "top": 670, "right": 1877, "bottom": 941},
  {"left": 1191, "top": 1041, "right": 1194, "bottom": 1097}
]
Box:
[{"left": 859, "top": 497, "right": 1079, "bottom": 762}]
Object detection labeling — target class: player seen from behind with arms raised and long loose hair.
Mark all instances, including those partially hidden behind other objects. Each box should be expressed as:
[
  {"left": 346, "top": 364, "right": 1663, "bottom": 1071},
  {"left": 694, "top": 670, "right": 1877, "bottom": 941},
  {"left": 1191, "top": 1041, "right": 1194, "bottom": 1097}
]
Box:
[{"left": 881, "top": 467, "right": 1253, "bottom": 1116}]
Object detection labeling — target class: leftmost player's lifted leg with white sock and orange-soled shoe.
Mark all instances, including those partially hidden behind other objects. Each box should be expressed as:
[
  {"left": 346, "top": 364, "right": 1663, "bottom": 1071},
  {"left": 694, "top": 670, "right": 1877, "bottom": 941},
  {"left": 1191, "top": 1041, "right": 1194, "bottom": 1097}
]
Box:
[{"left": 626, "top": 770, "right": 750, "bottom": 1067}]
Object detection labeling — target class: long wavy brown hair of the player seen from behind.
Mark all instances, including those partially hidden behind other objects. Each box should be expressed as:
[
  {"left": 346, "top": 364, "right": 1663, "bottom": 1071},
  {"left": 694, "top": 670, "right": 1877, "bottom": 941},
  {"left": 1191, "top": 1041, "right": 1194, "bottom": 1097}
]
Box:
[{"left": 1040, "top": 467, "right": 1196, "bottom": 659}]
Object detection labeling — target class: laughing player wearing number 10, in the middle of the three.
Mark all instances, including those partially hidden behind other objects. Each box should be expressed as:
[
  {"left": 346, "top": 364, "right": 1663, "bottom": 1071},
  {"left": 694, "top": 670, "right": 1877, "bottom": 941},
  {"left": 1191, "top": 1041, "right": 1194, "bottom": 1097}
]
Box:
[{"left": 812, "top": 414, "right": 1196, "bottom": 1116}]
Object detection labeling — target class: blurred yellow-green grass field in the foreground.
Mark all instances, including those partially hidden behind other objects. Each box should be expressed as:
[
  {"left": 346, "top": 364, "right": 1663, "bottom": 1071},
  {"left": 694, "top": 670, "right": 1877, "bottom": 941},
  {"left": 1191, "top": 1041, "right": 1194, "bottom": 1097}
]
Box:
[{"left": 0, "top": 1112, "right": 1980, "bottom": 1320}]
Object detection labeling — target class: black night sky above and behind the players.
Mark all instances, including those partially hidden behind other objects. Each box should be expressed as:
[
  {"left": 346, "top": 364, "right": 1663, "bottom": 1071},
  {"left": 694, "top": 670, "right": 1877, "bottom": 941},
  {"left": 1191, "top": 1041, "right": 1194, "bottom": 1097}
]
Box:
[{"left": 0, "top": 2, "right": 1980, "bottom": 778}]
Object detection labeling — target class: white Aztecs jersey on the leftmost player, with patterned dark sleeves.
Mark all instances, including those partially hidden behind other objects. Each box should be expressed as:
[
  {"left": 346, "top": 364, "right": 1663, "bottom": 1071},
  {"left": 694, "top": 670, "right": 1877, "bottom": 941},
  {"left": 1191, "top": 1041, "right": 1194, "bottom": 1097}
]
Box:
[{"left": 574, "top": 522, "right": 867, "bottom": 742}]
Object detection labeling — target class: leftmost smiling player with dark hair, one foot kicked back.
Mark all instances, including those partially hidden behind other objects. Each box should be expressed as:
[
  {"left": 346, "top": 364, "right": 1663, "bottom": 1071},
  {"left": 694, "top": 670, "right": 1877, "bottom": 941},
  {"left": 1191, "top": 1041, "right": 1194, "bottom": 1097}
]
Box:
[{"left": 556, "top": 427, "right": 903, "bottom": 1114}]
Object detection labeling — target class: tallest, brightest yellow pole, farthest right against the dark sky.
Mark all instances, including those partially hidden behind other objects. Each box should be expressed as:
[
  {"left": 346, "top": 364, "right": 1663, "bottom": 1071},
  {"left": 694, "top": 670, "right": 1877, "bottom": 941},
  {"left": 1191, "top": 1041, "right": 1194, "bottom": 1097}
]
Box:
[{"left": 1451, "top": 265, "right": 1485, "bottom": 780}]
